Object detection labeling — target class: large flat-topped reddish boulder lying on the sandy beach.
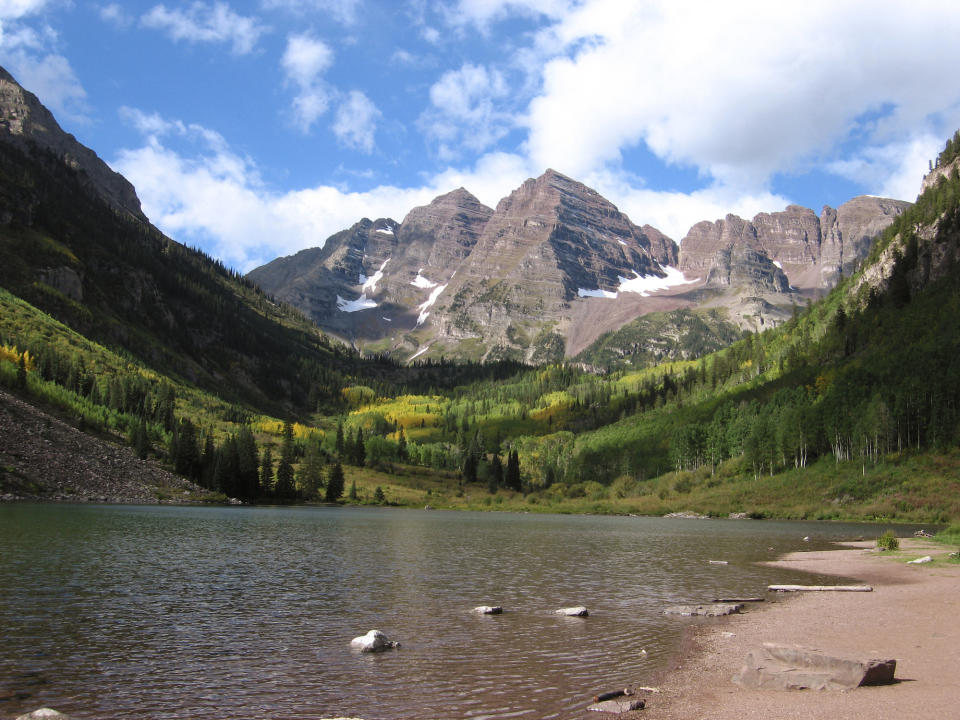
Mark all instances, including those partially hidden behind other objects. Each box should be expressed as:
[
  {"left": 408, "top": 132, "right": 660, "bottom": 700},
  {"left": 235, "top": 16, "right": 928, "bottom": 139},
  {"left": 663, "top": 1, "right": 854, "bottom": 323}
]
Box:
[{"left": 733, "top": 643, "right": 897, "bottom": 690}]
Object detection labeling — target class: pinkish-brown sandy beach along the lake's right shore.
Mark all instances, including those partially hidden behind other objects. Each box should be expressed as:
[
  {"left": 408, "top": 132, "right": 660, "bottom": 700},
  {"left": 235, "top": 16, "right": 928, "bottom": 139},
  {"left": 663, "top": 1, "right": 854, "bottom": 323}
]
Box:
[{"left": 600, "top": 539, "right": 960, "bottom": 720}]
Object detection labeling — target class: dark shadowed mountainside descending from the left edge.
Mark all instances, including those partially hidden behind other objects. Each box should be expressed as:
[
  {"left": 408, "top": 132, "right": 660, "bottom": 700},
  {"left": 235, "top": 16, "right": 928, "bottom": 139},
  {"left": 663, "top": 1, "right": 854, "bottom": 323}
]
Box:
[{"left": 0, "top": 70, "right": 355, "bottom": 414}]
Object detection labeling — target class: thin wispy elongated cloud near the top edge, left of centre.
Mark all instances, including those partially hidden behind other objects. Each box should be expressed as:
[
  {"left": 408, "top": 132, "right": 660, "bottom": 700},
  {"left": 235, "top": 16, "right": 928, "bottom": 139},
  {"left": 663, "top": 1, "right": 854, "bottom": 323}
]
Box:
[{"left": 140, "top": 2, "right": 267, "bottom": 55}]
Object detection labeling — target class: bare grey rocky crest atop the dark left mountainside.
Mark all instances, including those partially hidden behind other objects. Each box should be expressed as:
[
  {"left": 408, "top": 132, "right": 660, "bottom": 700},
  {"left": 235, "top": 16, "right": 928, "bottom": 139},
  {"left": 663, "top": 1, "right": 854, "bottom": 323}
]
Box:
[{"left": 0, "top": 68, "right": 147, "bottom": 221}]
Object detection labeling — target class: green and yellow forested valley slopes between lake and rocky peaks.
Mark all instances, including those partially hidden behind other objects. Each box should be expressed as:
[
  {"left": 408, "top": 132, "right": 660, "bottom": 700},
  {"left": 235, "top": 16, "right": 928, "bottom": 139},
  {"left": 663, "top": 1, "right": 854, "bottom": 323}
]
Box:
[{"left": 0, "top": 129, "right": 960, "bottom": 521}]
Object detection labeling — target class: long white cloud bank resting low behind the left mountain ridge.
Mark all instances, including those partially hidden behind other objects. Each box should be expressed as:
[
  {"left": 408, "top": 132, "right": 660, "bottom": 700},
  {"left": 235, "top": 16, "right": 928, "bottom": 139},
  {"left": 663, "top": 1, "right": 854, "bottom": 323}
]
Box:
[{"left": 111, "top": 108, "right": 540, "bottom": 271}]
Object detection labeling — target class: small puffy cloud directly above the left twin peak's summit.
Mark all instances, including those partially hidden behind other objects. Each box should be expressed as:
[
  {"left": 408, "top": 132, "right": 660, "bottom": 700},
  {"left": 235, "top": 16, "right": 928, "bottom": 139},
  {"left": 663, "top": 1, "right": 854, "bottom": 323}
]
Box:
[{"left": 420, "top": 63, "right": 513, "bottom": 158}]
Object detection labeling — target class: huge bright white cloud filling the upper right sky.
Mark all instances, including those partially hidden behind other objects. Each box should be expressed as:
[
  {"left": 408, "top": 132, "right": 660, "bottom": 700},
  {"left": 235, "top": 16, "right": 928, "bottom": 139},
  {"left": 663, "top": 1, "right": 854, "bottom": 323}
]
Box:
[{"left": 524, "top": 0, "right": 960, "bottom": 193}]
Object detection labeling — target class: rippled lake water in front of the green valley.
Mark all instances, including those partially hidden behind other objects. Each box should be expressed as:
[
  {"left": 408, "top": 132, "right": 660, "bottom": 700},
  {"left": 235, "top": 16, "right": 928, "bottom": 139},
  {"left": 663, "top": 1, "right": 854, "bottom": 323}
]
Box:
[{"left": 0, "top": 505, "right": 892, "bottom": 720}]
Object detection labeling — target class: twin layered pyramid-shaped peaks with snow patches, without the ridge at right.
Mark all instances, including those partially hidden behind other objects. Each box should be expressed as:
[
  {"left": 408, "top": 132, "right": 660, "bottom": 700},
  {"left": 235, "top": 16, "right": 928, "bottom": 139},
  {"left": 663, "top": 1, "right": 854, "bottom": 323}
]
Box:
[{"left": 250, "top": 170, "right": 682, "bottom": 361}]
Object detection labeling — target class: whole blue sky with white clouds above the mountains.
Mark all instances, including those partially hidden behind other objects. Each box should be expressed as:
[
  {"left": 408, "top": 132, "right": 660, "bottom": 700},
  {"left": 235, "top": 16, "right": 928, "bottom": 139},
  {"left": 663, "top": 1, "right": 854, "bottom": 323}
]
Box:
[{"left": 0, "top": 0, "right": 960, "bottom": 270}]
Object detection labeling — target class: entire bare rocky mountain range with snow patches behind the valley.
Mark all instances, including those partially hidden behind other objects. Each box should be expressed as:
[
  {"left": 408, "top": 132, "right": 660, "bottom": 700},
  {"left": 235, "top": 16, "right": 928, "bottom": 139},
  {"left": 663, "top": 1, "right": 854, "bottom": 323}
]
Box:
[{"left": 249, "top": 170, "right": 909, "bottom": 363}]
